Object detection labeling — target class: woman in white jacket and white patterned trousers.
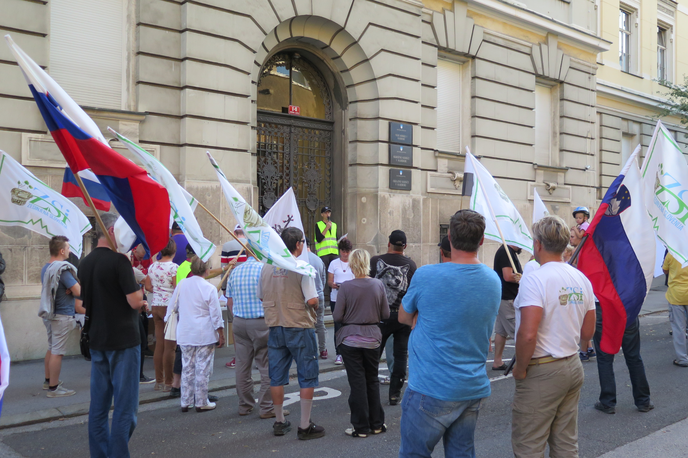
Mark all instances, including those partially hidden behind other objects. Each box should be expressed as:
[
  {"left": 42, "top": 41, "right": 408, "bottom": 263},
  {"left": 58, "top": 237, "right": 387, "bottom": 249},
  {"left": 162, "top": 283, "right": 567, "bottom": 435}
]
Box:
[{"left": 165, "top": 257, "right": 225, "bottom": 412}]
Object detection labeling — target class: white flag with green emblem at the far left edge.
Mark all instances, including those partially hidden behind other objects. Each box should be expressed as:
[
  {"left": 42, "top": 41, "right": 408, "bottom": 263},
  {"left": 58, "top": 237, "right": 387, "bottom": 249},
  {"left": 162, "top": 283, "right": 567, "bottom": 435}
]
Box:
[{"left": 0, "top": 151, "right": 91, "bottom": 257}]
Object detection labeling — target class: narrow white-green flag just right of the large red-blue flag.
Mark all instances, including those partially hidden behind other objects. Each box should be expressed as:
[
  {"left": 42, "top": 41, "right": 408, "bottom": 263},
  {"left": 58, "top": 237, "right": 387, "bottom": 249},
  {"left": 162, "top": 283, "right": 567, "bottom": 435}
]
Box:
[{"left": 109, "top": 129, "right": 215, "bottom": 261}]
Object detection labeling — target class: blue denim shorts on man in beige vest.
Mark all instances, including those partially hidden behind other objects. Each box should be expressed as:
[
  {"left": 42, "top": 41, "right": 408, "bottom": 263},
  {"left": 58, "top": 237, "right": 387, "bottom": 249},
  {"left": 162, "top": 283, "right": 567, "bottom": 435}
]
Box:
[{"left": 268, "top": 326, "right": 320, "bottom": 388}]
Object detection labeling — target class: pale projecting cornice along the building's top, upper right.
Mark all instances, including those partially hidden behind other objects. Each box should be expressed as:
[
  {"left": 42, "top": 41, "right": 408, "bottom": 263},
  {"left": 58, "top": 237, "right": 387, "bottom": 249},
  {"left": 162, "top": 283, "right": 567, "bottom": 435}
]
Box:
[{"left": 466, "top": 0, "right": 612, "bottom": 53}]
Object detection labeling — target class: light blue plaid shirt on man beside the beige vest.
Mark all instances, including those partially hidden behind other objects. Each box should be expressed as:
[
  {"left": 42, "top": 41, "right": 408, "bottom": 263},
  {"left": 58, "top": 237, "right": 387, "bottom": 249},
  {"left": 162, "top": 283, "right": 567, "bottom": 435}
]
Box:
[{"left": 227, "top": 258, "right": 264, "bottom": 319}]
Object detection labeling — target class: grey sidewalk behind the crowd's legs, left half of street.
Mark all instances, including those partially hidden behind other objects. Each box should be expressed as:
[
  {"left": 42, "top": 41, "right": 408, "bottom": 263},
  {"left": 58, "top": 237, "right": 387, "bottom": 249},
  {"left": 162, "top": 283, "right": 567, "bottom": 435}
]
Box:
[{"left": 0, "top": 315, "right": 344, "bottom": 429}]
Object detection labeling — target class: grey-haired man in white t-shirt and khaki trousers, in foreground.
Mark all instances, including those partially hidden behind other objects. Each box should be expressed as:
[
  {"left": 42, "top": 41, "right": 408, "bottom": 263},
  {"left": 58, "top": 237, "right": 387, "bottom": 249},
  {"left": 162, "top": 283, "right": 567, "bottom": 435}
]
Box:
[{"left": 511, "top": 216, "right": 595, "bottom": 458}]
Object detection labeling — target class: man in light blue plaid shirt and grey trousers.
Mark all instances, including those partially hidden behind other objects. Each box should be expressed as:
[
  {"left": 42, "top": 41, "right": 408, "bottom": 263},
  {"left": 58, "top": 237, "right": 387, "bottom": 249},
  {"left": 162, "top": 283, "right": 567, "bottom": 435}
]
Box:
[{"left": 226, "top": 257, "right": 289, "bottom": 419}]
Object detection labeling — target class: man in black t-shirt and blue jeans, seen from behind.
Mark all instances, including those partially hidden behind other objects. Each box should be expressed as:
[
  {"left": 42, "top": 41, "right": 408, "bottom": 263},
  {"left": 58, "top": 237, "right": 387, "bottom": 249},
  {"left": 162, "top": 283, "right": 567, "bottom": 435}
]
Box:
[{"left": 78, "top": 213, "right": 148, "bottom": 458}]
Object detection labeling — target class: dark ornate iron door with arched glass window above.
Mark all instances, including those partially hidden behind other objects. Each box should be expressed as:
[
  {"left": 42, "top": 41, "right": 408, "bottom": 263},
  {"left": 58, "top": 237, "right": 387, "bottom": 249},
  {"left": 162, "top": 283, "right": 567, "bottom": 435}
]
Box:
[{"left": 256, "top": 51, "right": 334, "bottom": 236}]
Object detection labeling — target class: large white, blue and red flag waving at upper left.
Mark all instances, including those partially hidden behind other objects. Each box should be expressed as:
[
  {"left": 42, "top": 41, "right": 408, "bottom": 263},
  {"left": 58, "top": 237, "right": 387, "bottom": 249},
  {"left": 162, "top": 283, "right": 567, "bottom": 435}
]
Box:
[{"left": 5, "top": 35, "right": 170, "bottom": 258}]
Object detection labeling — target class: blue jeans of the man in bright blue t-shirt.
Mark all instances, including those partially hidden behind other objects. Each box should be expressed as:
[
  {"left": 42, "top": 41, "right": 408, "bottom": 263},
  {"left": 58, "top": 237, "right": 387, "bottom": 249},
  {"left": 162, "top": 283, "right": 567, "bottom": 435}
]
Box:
[{"left": 399, "top": 388, "right": 482, "bottom": 458}]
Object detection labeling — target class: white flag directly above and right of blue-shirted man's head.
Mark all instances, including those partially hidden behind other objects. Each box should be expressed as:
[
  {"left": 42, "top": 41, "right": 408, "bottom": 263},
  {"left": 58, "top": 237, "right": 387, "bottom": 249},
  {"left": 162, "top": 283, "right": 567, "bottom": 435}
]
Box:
[{"left": 464, "top": 148, "right": 533, "bottom": 254}]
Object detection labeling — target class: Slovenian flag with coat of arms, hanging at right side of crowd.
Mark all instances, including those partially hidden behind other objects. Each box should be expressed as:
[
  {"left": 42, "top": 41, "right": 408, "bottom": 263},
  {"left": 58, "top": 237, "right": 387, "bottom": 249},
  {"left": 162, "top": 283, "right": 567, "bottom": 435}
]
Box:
[{"left": 578, "top": 145, "right": 655, "bottom": 355}]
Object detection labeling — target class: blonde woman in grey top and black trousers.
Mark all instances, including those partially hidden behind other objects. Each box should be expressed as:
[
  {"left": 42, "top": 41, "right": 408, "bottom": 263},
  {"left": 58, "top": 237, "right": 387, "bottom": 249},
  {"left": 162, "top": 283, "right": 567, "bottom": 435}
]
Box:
[{"left": 332, "top": 249, "right": 389, "bottom": 437}]
